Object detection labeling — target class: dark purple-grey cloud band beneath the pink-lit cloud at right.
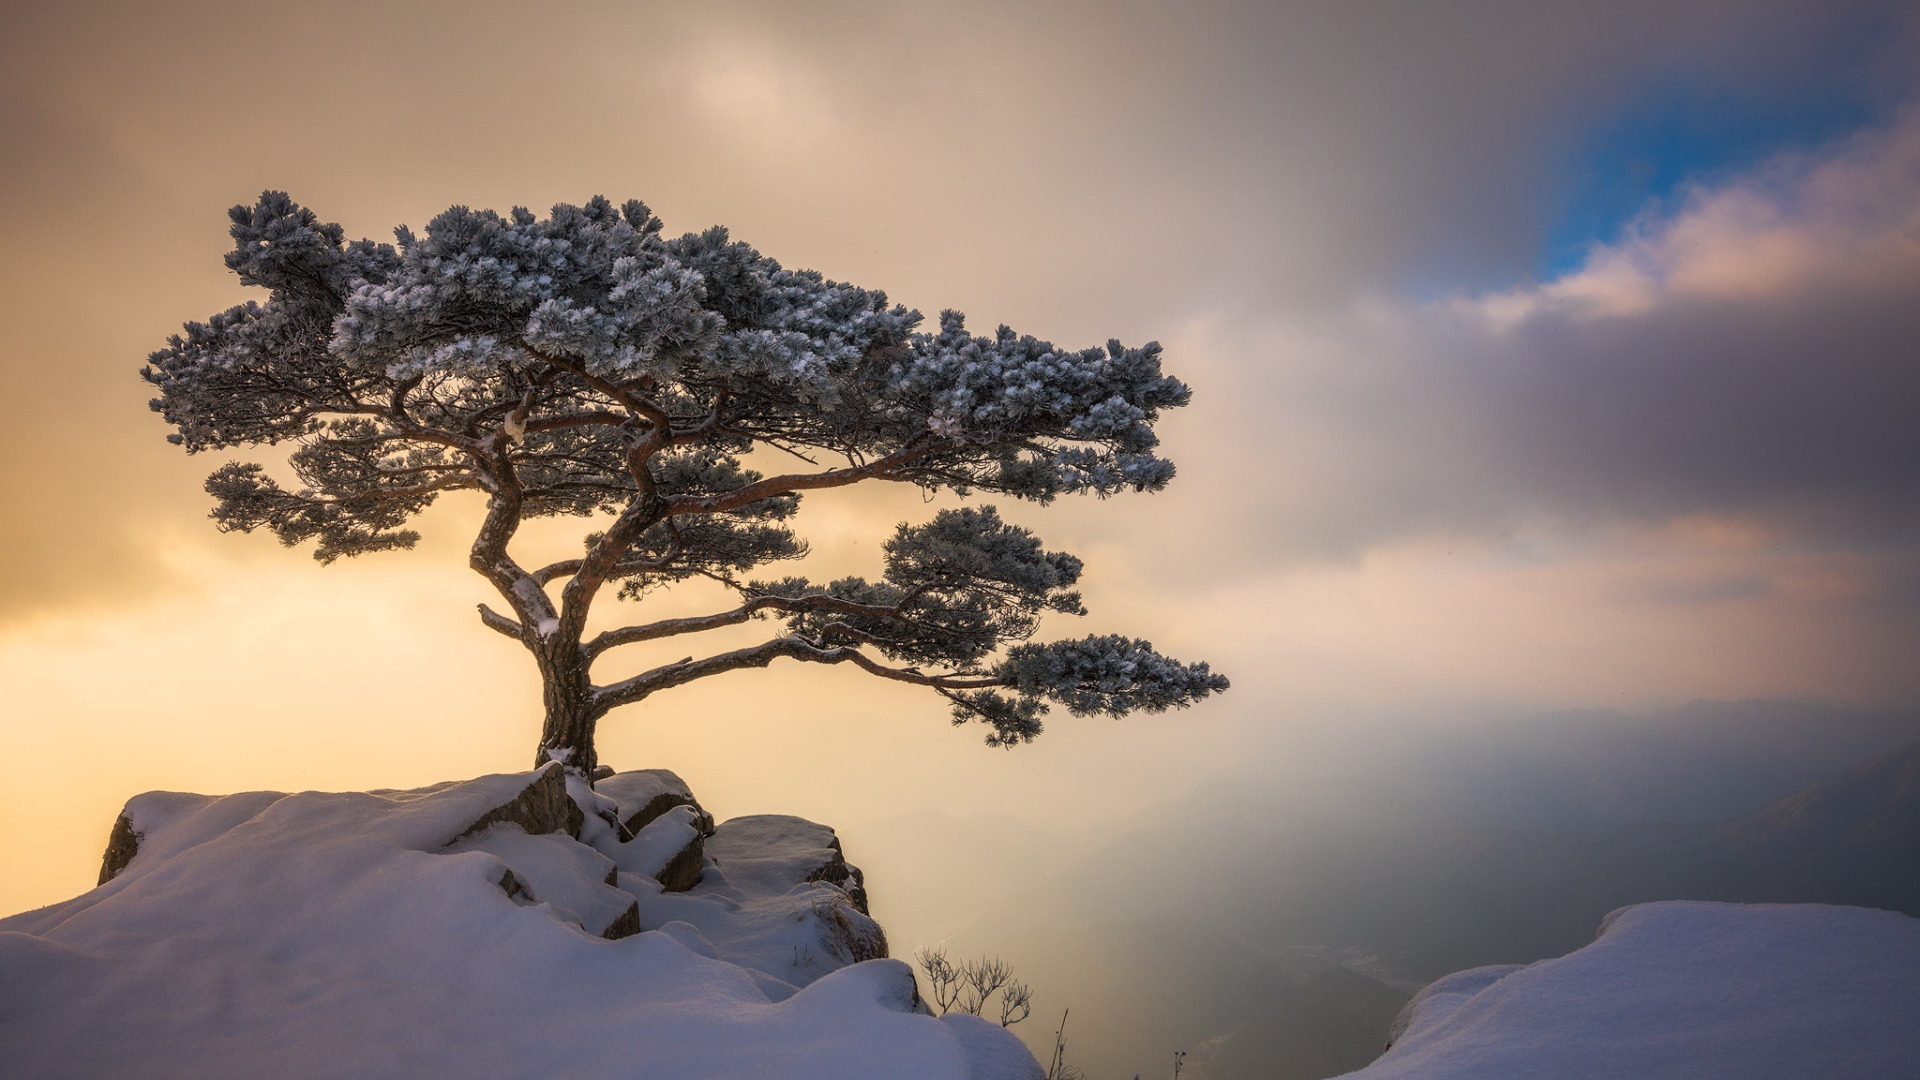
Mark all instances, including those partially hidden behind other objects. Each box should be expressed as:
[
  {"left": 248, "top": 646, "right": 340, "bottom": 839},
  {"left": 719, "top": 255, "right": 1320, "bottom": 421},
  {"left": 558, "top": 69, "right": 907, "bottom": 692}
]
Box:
[{"left": 1482, "top": 275, "right": 1920, "bottom": 540}]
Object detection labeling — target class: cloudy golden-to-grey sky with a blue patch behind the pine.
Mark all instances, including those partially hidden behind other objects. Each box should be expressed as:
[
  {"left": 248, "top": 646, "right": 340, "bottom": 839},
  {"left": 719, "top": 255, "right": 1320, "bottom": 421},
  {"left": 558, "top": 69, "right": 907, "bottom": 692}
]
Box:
[{"left": 0, "top": 0, "right": 1920, "bottom": 911}]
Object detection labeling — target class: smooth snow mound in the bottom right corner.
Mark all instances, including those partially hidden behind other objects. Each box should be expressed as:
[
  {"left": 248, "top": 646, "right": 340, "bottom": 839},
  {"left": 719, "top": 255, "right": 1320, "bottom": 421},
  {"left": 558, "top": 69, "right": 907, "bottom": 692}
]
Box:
[{"left": 1348, "top": 901, "right": 1920, "bottom": 1080}]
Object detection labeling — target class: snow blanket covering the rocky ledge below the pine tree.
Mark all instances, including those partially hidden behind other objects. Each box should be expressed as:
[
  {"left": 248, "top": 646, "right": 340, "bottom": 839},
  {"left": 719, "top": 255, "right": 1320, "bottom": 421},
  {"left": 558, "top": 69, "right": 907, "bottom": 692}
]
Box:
[{"left": 0, "top": 774, "right": 1039, "bottom": 1080}]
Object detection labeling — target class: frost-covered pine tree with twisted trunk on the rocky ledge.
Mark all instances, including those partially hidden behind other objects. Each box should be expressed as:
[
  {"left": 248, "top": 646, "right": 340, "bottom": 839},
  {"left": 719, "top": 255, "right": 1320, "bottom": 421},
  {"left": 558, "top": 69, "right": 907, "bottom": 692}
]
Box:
[{"left": 142, "top": 192, "right": 1227, "bottom": 773}]
